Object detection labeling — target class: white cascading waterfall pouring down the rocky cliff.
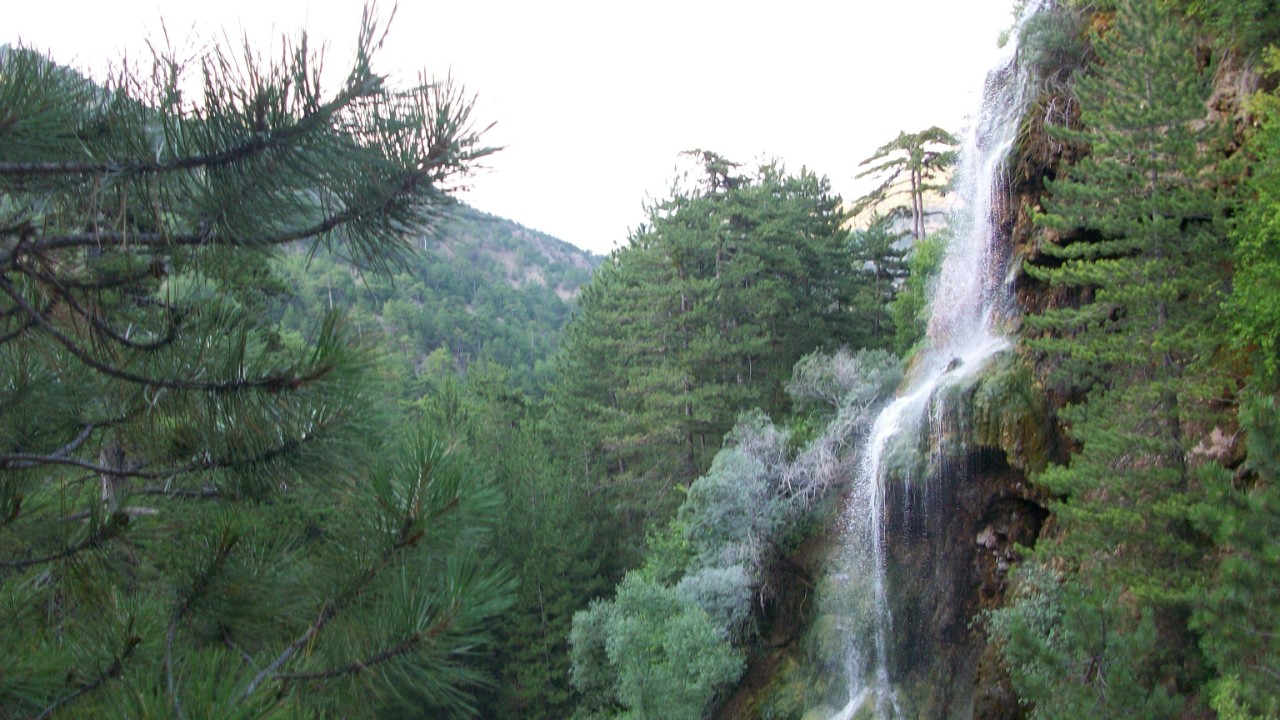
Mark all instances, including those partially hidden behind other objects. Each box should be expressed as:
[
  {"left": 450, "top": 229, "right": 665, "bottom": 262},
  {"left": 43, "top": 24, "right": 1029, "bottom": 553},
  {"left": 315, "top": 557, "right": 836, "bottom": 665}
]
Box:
[{"left": 832, "top": 4, "right": 1037, "bottom": 720}]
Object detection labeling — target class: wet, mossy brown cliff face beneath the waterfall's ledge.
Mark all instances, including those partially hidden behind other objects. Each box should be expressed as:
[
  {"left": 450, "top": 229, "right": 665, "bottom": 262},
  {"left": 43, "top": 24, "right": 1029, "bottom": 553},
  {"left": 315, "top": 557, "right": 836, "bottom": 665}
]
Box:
[{"left": 886, "top": 352, "right": 1062, "bottom": 720}]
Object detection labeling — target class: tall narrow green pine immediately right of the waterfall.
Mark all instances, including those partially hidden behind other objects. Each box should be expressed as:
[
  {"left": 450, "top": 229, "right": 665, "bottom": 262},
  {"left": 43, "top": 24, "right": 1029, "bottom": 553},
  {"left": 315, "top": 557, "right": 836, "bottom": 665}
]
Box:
[{"left": 1028, "top": 3, "right": 1229, "bottom": 591}]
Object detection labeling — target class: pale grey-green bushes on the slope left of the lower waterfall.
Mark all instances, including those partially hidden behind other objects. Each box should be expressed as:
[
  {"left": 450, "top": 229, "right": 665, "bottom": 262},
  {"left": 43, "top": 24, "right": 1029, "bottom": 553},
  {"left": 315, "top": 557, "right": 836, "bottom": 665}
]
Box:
[{"left": 570, "top": 350, "right": 901, "bottom": 720}]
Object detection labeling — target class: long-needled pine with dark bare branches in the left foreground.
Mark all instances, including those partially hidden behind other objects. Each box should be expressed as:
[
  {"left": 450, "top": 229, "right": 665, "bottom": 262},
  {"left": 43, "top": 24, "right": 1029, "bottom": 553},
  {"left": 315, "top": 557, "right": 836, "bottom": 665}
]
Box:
[{"left": 0, "top": 13, "right": 508, "bottom": 717}]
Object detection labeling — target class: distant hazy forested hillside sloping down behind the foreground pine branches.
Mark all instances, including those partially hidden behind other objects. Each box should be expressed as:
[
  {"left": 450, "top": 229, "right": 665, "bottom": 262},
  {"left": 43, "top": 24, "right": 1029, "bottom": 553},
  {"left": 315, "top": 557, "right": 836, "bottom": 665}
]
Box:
[{"left": 270, "top": 205, "right": 600, "bottom": 389}]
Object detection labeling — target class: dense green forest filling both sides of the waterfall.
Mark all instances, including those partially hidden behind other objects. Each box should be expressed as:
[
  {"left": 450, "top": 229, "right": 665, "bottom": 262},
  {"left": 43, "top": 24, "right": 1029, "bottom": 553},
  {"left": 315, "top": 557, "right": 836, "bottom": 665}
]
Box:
[{"left": 0, "top": 0, "right": 1280, "bottom": 720}]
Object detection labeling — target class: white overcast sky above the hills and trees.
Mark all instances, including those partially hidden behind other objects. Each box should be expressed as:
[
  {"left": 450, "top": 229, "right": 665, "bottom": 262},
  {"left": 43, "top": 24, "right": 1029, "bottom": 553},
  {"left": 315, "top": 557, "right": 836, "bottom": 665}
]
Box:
[{"left": 0, "top": 0, "right": 1012, "bottom": 252}]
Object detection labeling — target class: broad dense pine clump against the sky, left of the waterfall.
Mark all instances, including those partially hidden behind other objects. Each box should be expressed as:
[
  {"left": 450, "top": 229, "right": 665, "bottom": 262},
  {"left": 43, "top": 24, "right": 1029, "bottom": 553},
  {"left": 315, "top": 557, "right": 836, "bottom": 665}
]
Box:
[{"left": 553, "top": 152, "right": 854, "bottom": 538}]
